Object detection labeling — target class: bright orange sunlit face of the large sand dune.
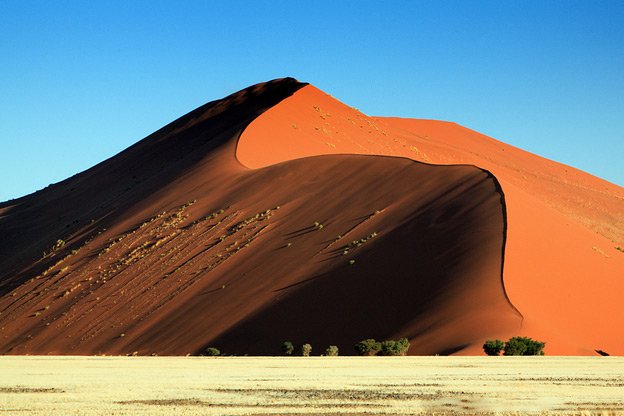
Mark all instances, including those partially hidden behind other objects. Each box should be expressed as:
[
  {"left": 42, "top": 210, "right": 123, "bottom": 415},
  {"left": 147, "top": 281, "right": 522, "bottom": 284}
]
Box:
[{"left": 237, "top": 85, "right": 624, "bottom": 354}]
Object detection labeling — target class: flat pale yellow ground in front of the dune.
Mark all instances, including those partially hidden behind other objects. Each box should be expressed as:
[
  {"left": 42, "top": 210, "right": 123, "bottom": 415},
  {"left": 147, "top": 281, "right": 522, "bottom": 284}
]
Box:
[{"left": 0, "top": 356, "right": 624, "bottom": 415}]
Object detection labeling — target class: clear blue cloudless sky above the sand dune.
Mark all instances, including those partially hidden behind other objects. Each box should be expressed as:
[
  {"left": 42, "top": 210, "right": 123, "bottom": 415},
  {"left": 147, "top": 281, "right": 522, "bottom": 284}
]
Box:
[{"left": 0, "top": 0, "right": 624, "bottom": 201}]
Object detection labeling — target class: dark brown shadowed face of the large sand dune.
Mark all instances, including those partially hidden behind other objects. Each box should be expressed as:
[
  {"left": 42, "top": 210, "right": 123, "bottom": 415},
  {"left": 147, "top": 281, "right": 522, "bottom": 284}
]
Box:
[{"left": 0, "top": 78, "right": 521, "bottom": 354}]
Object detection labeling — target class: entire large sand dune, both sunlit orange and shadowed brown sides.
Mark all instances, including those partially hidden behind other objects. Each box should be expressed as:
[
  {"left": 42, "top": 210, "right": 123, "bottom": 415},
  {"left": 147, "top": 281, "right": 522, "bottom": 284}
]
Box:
[{"left": 0, "top": 78, "right": 624, "bottom": 354}]
